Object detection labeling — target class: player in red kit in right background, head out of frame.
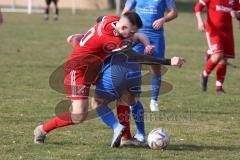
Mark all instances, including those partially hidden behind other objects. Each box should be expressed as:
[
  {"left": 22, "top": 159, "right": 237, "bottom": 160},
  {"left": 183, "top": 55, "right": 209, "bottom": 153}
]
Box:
[{"left": 195, "top": 0, "right": 240, "bottom": 94}]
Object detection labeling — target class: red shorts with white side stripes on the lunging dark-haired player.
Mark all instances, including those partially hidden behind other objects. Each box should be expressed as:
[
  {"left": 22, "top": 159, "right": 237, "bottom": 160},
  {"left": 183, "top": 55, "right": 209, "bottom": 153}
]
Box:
[{"left": 64, "top": 55, "right": 102, "bottom": 100}]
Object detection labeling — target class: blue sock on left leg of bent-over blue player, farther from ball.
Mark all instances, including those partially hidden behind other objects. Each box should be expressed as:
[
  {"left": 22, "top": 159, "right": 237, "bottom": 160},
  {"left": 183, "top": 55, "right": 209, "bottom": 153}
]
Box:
[{"left": 96, "top": 105, "right": 120, "bottom": 131}]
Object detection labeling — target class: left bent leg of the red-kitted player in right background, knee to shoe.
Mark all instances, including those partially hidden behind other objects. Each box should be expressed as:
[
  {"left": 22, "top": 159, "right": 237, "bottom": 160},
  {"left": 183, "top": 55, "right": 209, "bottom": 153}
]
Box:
[{"left": 200, "top": 53, "right": 223, "bottom": 92}]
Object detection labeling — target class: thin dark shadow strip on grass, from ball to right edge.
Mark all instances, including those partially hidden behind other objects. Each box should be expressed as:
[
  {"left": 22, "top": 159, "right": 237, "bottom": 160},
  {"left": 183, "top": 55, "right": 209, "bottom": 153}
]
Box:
[{"left": 167, "top": 144, "right": 240, "bottom": 152}]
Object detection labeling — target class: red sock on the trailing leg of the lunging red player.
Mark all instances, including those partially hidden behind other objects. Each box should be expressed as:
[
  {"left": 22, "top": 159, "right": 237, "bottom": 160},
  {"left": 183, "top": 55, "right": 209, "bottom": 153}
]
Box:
[{"left": 43, "top": 113, "right": 74, "bottom": 133}]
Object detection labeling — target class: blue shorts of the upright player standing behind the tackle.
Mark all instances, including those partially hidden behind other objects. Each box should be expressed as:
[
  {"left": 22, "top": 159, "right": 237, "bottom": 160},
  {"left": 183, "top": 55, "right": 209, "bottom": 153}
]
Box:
[{"left": 133, "top": 32, "right": 165, "bottom": 58}]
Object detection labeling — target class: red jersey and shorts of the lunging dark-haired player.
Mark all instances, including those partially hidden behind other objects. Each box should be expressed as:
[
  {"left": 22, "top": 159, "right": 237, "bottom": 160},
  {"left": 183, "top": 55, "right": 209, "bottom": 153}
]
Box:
[{"left": 64, "top": 16, "right": 124, "bottom": 99}]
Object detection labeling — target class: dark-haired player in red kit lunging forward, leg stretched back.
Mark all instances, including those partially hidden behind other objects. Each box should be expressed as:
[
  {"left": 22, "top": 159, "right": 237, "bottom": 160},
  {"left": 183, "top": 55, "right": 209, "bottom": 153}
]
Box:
[{"left": 34, "top": 12, "right": 146, "bottom": 144}]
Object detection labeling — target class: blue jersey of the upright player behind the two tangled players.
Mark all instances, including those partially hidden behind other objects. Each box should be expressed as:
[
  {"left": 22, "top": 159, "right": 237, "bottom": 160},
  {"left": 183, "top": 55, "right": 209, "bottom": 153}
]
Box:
[{"left": 125, "top": 0, "right": 176, "bottom": 33}]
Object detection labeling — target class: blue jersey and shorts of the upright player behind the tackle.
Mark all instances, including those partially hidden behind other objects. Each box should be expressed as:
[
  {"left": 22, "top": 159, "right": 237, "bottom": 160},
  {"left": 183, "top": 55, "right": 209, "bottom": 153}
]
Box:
[{"left": 125, "top": 0, "right": 176, "bottom": 58}]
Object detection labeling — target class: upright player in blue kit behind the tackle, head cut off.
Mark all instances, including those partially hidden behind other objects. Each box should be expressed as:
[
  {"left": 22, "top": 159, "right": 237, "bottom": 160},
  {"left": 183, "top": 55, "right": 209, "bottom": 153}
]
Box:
[{"left": 123, "top": 0, "right": 177, "bottom": 111}]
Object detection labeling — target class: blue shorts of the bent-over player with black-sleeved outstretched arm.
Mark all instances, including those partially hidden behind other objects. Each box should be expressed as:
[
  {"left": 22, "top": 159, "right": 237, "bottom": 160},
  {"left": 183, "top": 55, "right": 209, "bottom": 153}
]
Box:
[{"left": 95, "top": 54, "right": 141, "bottom": 101}]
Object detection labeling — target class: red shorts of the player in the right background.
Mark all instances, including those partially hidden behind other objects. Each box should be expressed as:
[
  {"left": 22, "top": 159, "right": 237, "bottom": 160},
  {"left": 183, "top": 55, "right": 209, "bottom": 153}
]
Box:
[{"left": 206, "top": 30, "right": 235, "bottom": 58}]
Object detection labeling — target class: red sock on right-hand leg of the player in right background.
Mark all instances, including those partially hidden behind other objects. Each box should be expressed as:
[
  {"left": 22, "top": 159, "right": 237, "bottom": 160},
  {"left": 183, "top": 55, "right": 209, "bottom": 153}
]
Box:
[{"left": 216, "top": 64, "right": 227, "bottom": 89}]
